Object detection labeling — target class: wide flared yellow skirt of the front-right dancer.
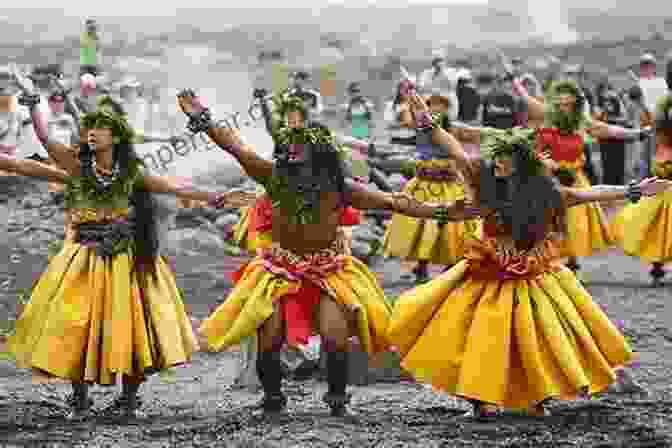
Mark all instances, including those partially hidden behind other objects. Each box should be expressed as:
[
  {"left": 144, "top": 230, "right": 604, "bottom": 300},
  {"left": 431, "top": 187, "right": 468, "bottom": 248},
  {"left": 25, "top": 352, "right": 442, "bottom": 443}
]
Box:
[{"left": 388, "top": 238, "right": 634, "bottom": 409}]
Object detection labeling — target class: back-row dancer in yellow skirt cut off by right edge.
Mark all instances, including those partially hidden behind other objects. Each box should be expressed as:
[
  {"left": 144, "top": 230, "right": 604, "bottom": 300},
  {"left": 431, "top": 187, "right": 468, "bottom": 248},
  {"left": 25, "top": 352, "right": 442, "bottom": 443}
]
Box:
[{"left": 612, "top": 94, "right": 672, "bottom": 286}]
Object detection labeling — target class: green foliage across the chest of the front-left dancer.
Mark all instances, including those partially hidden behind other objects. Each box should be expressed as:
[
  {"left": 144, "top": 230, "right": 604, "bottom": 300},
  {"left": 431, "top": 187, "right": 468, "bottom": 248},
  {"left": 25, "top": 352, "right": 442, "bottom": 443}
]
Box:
[{"left": 64, "top": 160, "right": 143, "bottom": 208}]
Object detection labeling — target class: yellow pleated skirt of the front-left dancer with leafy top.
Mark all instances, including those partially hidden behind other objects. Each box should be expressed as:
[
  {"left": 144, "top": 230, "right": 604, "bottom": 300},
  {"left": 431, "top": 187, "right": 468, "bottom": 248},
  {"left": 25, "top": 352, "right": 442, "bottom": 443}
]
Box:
[{"left": 8, "top": 241, "right": 198, "bottom": 385}]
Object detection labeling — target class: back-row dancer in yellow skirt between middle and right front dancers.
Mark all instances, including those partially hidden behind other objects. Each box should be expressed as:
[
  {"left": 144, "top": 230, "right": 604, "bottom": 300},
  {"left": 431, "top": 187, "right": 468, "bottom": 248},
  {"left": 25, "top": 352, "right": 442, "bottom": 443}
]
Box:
[{"left": 383, "top": 91, "right": 479, "bottom": 283}]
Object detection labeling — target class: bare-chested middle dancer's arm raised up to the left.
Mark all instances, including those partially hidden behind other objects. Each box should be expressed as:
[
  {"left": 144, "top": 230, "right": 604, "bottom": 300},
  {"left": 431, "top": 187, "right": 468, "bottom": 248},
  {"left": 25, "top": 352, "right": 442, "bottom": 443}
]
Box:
[{"left": 178, "top": 90, "right": 273, "bottom": 183}]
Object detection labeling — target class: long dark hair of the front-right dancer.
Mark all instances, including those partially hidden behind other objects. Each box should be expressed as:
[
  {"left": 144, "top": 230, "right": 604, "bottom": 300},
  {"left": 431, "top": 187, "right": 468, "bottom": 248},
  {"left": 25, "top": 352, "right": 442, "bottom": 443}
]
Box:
[{"left": 479, "top": 146, "right": 566, "bottom": 248}]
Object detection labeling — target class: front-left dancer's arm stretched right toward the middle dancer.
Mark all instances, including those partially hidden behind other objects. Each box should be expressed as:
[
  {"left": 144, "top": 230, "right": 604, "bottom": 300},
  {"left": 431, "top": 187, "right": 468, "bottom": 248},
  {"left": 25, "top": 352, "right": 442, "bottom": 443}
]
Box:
[{"left": 142, "top": 175, "right": 257, "bottom": 208}]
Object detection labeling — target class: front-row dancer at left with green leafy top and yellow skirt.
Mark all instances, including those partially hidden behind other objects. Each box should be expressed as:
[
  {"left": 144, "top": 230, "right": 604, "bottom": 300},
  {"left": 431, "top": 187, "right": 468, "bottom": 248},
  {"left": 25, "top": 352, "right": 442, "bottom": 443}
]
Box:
[{"left": 8, "top": 78, "right": 254, "bottom": 418}]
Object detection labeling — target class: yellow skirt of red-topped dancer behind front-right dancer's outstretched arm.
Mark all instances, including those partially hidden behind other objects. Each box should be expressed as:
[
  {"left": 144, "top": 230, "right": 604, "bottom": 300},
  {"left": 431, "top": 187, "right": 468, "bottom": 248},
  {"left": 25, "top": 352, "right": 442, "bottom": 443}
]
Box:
[{"left": 561, "top": 170, "right": 614, "bottom": 257}]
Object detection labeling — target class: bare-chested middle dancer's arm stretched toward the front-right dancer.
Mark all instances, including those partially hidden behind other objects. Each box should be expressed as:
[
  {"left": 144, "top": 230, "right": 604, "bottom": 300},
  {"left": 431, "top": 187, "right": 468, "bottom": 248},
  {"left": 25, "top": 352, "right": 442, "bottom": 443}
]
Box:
[{"left": 347, "top": 177, "right": 478, "bottom": 223}]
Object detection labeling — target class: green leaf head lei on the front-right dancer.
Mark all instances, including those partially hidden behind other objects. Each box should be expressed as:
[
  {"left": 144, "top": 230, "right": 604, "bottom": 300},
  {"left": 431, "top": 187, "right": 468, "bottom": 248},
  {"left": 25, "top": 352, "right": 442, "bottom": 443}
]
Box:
[{"left": 481, "top": 127, "right": 544, "bottom": 175}]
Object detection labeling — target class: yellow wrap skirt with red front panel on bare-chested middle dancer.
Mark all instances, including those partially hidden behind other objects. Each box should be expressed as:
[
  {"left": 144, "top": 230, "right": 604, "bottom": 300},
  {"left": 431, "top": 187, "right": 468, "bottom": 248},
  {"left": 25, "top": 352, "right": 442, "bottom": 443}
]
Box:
[{"left": 199, "top": 237, "right": 391, "bottom": 353}]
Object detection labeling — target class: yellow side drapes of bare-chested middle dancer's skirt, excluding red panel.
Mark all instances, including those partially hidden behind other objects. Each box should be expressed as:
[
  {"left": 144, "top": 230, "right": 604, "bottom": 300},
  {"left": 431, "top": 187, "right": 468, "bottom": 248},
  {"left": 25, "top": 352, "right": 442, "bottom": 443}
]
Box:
[{"left": 199, "top": 252, "right": 391, "bottom": 353}]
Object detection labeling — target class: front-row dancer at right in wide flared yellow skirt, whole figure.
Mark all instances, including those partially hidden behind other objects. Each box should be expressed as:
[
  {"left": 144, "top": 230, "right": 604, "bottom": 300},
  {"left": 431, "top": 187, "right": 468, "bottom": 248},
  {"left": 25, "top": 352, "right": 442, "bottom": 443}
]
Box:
[{"left": 388, "top": 93, "right": 672, "bottom": 418}]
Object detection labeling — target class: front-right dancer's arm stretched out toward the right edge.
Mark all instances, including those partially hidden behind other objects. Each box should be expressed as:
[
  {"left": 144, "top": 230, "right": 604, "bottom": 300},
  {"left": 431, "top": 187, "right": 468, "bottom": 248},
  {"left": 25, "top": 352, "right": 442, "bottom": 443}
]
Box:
[{"left": 561, "top": 177, "right": 672, "bottom": 207}]
